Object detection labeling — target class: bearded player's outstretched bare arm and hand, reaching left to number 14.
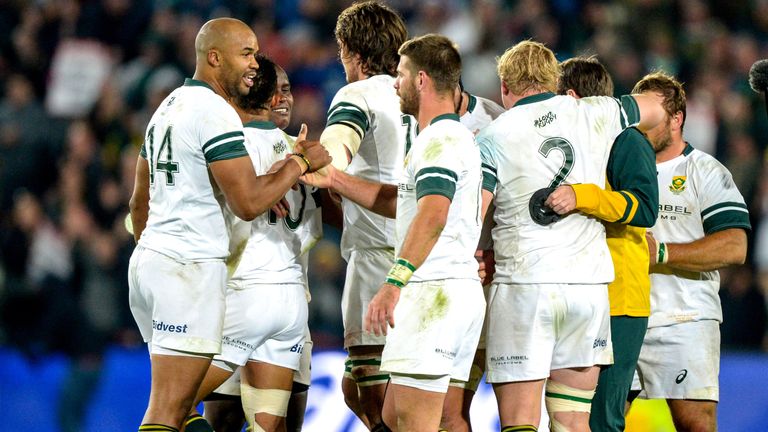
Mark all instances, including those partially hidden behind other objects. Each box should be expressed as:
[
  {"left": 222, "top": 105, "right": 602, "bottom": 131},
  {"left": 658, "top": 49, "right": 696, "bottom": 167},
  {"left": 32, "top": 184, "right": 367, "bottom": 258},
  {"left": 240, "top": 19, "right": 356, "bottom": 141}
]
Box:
[{"left": 301, "top": 165, "right": 397, "bottom": 218}]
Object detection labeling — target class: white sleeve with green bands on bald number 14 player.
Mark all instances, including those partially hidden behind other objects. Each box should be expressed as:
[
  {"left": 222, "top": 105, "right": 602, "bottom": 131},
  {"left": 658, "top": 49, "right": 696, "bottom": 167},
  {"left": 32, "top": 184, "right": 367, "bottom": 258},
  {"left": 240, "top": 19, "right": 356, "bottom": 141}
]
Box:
[{"left": 198, "top": 102, "right": 248, "bottom": 163}]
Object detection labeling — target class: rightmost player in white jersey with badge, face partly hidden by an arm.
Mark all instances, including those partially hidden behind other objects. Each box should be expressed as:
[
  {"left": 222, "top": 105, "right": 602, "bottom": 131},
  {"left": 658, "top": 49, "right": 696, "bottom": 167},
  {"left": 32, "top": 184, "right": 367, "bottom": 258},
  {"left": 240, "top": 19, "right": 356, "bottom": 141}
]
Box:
[{"left": 633, "top": 72, "right": 751, "bottom": 431}]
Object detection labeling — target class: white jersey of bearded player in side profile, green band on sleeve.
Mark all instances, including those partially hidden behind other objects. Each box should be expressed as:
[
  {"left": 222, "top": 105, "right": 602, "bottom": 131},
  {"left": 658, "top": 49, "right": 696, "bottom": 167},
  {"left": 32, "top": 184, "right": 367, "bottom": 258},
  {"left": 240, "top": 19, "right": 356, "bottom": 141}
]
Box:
[{"left": 395, "top": 114, "right": 482, "bottom": 282}]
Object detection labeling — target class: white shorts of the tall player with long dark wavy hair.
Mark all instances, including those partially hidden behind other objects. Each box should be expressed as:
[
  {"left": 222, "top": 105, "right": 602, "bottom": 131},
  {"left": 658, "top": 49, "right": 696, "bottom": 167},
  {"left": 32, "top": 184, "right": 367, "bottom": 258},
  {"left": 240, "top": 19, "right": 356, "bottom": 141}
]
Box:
[{"left": 341, "top": 249, "right": 395, "bottom": 348}]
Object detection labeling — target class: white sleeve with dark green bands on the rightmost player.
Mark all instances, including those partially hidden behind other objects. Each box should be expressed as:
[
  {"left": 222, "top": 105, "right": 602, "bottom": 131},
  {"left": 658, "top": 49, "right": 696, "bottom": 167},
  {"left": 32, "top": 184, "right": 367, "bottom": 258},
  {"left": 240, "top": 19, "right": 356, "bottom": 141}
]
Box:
[{"left": 696, "top": 158, "right": 752, "bottom": 234}]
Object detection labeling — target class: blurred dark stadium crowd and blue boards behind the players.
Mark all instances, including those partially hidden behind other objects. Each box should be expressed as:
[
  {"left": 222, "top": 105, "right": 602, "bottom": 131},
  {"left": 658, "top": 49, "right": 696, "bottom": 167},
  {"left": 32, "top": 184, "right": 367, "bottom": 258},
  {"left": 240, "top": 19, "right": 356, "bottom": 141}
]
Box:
[{"left": 0, "top": 0, "right": 768, "bottom": 432}]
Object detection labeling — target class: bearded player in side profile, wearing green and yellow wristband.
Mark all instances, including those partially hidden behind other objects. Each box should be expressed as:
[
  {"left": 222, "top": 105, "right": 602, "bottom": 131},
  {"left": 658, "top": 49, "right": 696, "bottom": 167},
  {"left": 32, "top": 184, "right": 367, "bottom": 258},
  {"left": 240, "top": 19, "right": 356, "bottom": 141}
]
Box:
[{"left": 305, "top": 35, "right": 485, "bottom": 431}]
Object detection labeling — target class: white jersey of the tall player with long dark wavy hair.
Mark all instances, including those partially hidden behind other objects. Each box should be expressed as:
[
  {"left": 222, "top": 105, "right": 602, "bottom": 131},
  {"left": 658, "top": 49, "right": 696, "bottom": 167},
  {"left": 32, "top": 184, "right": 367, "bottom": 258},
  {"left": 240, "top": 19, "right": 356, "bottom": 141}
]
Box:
[{"left": 327, "top": 75, "right": 408, "bottom": 259}]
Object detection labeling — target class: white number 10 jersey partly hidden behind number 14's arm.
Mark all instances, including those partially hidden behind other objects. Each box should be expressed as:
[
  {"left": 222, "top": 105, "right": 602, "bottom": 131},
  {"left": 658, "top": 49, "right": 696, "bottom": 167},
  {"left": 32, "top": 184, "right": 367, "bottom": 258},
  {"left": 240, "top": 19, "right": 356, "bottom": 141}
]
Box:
[{"left": 227, "top": 122, "right": 323, "bottom": 286}]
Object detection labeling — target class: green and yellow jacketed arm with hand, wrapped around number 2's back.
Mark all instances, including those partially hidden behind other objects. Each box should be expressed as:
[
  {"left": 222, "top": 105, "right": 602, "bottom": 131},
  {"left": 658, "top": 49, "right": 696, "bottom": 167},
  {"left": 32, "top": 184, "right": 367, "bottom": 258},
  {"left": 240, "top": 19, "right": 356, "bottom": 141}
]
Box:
[{"left": 545, "top": 128, "right": 659, "bottom": 228}]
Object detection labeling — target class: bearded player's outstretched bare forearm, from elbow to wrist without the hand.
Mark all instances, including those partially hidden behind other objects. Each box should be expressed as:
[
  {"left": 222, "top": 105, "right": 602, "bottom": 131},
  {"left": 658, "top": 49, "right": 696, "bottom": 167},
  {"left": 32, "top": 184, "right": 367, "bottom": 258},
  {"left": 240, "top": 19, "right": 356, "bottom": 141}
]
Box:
[{"left": 331, "top": 171, "right": 397, "bottom": 218}]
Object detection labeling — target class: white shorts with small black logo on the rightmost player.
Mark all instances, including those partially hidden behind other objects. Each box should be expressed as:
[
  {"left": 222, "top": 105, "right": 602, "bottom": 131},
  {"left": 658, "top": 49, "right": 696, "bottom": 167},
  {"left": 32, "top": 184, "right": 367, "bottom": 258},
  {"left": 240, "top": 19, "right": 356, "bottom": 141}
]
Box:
[{"left": 638, "top": 320, "right": 720, "bottom": 402}]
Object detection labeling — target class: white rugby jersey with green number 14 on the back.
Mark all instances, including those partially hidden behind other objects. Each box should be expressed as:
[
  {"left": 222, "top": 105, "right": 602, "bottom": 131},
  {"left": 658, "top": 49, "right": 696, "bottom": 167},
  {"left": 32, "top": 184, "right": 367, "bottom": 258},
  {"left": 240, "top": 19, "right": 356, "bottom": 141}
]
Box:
[{"left": 139, "top": 79, "right": 248, "bottom": 261}]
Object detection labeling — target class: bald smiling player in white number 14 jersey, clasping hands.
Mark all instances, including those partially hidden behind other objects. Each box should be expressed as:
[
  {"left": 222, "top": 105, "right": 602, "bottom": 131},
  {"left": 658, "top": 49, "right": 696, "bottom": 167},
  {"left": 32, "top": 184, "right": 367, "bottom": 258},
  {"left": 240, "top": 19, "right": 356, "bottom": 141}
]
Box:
[{"left": 128, "top": 18, "right": 330, "bottom": 431}]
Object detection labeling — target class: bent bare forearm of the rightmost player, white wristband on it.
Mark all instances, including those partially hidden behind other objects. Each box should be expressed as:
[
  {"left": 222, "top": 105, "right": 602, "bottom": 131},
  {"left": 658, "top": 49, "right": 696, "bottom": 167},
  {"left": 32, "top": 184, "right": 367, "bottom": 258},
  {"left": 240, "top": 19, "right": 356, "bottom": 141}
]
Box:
[{"left": 646, "top": 228, "right": 747, "bottom": 272}]
